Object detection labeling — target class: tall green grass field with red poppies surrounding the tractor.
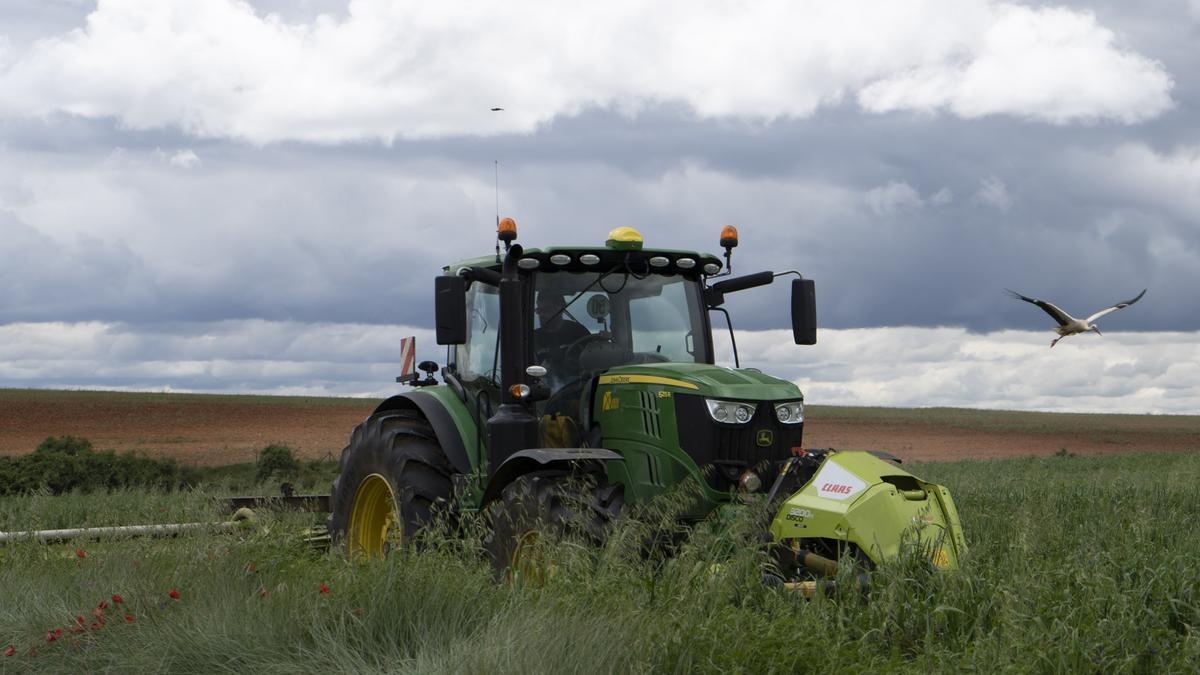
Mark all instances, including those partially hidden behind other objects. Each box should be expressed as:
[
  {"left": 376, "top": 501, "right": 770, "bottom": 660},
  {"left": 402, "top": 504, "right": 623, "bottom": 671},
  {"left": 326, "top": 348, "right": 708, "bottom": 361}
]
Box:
[{"left": 0, "top": 454, "right": 1200, "bottom": 673}]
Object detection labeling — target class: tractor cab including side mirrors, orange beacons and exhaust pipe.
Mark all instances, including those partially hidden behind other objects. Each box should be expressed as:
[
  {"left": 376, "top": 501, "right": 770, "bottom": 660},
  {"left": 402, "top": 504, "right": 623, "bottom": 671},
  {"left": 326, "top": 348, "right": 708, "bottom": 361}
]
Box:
[{"left": 437, "top": 219, "right": 816, "bottom": 466}]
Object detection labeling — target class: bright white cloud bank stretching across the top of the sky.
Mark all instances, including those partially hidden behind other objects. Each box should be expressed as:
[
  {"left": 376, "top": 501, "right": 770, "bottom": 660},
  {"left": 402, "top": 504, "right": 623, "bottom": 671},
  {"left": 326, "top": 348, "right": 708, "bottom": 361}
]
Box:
[{"left": 0, "top": 0, "right": 1172, "bottom": 143}]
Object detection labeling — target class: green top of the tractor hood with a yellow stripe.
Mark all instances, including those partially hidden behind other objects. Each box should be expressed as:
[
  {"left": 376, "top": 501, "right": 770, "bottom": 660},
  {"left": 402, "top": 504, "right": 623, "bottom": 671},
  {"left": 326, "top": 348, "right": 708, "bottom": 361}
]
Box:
[{"left": 600, "top": 363, "right": 804, "bottom": 401}]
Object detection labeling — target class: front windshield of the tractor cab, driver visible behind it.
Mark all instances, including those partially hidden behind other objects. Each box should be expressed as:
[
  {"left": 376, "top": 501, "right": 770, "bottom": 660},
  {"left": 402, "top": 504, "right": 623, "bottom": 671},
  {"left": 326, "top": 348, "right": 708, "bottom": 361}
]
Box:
[{"left": 533, "top": 270, "right": 709, "bottom": 377}]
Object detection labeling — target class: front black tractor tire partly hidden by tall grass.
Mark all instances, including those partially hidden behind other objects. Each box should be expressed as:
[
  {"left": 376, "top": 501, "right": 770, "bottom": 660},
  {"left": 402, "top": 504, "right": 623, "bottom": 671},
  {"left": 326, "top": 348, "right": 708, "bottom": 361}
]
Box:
[{"left": 484, "top": 470, "right": 625, "bottom": 580}]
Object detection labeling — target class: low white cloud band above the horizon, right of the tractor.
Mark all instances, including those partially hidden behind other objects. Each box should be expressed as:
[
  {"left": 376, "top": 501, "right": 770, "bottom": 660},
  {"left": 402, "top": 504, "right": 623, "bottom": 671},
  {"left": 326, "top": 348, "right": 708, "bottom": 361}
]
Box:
[{"left": 714, "top": 328, "right": 1200, "bottom": 414}]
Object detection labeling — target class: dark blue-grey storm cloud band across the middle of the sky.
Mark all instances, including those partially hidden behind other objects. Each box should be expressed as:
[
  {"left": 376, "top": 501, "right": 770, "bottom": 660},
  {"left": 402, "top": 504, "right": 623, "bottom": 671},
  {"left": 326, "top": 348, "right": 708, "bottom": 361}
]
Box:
[{"left": 0, "top": 102, "right": 1200, "bottom": 330}]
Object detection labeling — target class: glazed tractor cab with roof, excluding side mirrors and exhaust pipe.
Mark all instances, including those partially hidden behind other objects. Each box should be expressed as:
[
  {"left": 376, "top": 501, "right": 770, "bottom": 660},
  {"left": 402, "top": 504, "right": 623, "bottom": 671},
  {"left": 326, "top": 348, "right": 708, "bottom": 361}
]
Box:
[{"left": 450, "top": 228, "right": 721, "bottom": 447}]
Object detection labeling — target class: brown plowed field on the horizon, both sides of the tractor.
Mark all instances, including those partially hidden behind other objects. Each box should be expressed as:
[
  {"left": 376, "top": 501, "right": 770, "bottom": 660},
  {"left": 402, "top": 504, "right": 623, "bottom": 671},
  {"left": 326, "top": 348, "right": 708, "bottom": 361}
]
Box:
[{"left": 0, "top": 389, "right": 1200, "bottom": 464}]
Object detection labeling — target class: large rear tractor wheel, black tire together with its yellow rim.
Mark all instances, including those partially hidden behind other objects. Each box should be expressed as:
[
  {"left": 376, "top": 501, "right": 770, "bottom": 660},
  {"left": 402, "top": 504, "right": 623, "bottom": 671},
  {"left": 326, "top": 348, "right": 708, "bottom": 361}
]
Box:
[{"left": 329, "top": 410, "right": 454, "bottom": 560}]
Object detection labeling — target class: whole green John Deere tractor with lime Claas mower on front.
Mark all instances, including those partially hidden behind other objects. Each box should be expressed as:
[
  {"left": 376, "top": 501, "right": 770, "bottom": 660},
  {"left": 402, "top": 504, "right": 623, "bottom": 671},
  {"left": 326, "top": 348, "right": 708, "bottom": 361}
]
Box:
[{"left": 330, "top": 219, "right": 966, "bottom": 591}]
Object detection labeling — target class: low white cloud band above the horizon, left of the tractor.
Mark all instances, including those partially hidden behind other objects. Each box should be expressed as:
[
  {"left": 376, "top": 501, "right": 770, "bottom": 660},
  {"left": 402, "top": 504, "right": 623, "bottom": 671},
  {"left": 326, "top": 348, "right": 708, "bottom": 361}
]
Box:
[{"left": 0, "top": 321, "right": 445, "bottom": 396}]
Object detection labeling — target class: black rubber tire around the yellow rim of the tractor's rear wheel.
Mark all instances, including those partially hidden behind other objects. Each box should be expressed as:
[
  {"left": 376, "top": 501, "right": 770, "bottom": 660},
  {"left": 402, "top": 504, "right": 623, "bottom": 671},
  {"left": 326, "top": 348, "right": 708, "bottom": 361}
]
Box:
[{"left": 329, "top": 410, "right": 454, "bottom": 552}]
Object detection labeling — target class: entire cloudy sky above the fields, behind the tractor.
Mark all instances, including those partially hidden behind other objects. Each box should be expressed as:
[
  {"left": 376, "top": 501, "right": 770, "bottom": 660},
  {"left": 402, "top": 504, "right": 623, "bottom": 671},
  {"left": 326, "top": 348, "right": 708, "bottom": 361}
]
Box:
[{"left": 0, "top": 0, "right": 1200, "bottom": 413}]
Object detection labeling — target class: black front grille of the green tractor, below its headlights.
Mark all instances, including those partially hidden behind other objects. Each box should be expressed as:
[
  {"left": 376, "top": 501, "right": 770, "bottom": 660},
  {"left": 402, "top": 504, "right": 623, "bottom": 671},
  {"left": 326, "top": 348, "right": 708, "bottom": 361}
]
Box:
[{"left": 674, "top": 394, "right": 804, "bottom": 491}]
